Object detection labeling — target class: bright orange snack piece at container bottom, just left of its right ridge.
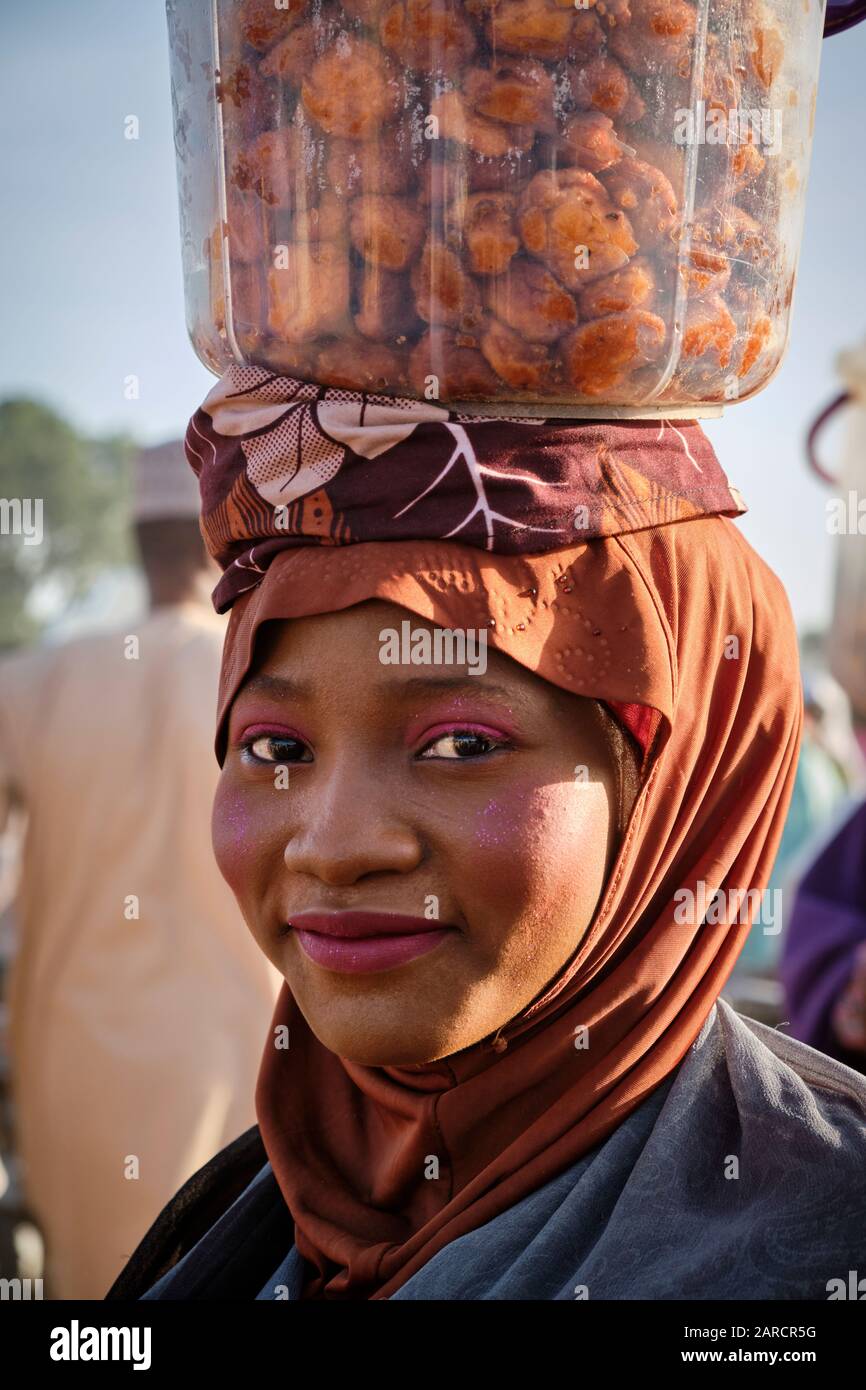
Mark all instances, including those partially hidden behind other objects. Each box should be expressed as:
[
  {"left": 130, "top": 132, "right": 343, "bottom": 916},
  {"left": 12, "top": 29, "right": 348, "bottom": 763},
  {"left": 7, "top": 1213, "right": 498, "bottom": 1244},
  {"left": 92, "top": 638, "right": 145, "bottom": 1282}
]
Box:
[{"left": 562, "top": 309, "right": 666, "bottom": 396}]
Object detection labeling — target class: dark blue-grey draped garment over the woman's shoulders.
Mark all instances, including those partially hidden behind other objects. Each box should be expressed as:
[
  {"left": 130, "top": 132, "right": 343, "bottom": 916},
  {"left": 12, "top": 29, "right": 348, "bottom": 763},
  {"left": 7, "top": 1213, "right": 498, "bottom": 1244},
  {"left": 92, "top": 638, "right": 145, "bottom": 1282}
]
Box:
[{"left": 142, "top": 999, "right": 866, "bottom": 1301}]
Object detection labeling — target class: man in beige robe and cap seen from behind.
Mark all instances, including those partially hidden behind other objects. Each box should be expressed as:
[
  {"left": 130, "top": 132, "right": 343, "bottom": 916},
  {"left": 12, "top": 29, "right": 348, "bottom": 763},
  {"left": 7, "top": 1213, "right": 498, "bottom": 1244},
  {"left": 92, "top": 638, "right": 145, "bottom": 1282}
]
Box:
[{"left": 0, "top": 442, "right": 281, "bottom": 1298}]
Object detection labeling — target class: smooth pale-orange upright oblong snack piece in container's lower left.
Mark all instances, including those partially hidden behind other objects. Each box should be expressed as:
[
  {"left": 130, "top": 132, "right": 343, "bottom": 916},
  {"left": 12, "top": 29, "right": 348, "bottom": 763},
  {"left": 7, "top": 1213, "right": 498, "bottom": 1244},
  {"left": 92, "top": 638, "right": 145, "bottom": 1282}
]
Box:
[{"left": 268, "top": 242, "right": 349, "bottom": 342}]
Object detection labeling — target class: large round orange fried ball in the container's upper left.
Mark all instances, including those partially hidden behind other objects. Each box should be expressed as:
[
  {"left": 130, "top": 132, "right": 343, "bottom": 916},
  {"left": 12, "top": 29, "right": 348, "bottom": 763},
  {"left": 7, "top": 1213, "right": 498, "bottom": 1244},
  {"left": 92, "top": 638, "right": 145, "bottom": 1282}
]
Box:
[{"left": 300, "top": 32, "right": 403, "bottom": 140}]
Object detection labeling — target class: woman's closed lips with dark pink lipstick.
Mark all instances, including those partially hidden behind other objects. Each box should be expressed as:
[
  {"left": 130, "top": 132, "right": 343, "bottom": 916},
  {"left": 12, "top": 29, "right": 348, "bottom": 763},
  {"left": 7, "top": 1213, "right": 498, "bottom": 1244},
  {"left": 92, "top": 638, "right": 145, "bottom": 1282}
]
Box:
[{"left": 289, "top": 912, "right": 453, "bottom": 974}]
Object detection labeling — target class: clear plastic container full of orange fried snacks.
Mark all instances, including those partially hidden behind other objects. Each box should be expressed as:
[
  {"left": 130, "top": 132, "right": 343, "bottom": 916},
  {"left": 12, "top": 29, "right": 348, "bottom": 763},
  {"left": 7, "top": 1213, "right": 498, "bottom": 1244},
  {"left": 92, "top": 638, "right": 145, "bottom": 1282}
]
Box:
[{"left": 167, "top": 0, "right": 824, "bottom": 414}]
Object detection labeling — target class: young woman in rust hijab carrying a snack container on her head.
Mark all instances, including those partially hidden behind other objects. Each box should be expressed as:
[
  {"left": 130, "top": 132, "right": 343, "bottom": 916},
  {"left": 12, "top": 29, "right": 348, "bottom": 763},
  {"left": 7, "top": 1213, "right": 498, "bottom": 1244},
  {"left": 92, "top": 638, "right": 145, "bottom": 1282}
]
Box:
[{"left": 108, "top": 371, "right": 866, "bottom": 1300}]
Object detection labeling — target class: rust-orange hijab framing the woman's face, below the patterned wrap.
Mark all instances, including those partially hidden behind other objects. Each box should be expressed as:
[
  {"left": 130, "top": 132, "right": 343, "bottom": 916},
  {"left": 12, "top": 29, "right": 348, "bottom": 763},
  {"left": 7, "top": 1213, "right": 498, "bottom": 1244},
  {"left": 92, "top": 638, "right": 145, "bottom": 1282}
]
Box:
[{"left": 211, "top": 516, "right": 802, "bottom": 1298}]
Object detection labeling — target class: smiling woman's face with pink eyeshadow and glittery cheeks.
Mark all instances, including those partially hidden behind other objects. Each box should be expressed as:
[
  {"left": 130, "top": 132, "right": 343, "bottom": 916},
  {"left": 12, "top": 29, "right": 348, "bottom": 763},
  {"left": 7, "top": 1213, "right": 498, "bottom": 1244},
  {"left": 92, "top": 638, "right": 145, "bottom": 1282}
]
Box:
[{"left": 213, "top": 599, "right": 633, "bottom": 1066}]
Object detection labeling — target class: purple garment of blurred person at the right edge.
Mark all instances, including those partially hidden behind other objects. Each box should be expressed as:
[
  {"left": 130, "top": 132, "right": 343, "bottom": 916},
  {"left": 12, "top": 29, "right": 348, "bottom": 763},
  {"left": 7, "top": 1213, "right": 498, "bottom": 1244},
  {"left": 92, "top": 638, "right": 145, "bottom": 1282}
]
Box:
[{"left": 778, "top": 801, "right": 866, "bottom": 1072}]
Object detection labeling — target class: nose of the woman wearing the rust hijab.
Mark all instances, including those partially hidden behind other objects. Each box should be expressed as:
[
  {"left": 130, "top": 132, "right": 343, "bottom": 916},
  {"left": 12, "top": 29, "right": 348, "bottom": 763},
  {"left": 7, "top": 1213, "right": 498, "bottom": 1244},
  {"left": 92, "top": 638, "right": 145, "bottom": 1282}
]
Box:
[{"left": 284, "top": 766, "right": 424, "bottom": 887}]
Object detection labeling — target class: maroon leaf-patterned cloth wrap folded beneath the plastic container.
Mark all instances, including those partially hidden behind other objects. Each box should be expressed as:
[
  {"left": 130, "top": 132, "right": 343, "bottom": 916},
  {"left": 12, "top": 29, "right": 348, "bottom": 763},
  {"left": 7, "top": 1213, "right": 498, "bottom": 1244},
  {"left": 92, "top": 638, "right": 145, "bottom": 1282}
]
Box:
[{"left": 186, "top": 367, "right": 746, "bottom": 762}]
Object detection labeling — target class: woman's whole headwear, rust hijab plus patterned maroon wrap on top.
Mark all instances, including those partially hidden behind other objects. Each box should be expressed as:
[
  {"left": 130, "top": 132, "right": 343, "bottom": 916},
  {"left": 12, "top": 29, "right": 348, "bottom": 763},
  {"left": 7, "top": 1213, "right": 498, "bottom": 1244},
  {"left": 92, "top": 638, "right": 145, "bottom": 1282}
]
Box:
[{"left": 188, "top": 373, "right": 802, "bottom": 1298}]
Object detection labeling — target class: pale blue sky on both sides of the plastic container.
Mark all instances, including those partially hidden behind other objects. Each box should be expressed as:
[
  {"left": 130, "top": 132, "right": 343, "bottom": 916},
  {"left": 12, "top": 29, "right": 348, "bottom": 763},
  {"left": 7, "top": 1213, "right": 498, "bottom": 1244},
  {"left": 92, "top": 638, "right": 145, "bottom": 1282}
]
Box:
[{"left": 0, "top": 0, "right": 866, "bottom": 628}]
